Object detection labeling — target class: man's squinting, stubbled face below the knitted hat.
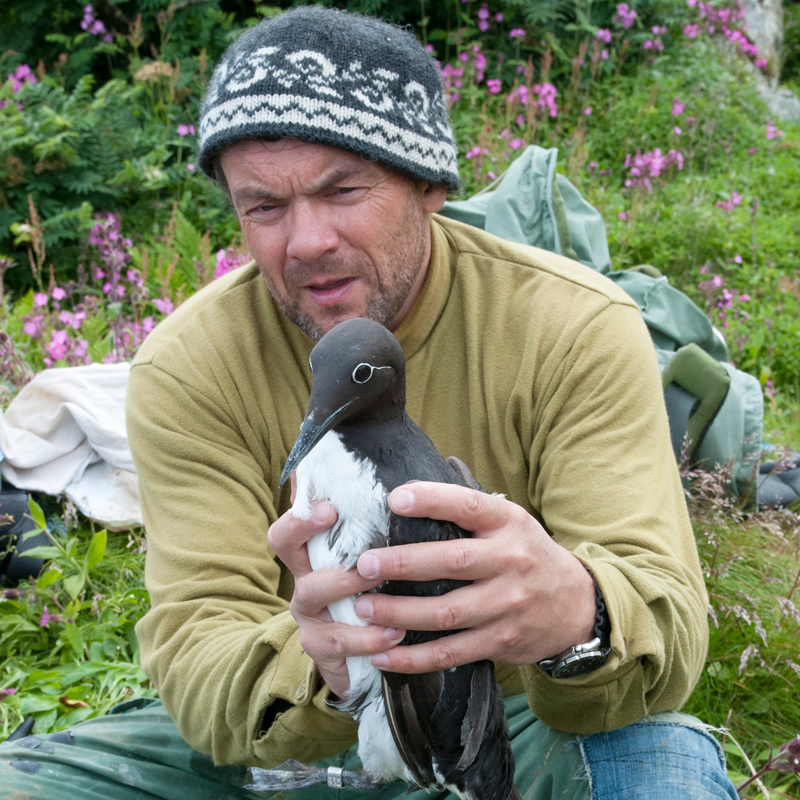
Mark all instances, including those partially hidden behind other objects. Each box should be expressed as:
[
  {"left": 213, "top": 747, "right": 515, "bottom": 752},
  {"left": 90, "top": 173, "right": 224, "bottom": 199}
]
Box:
[{"left": 220, "top": 139, "right": 446, "bottom": 339}]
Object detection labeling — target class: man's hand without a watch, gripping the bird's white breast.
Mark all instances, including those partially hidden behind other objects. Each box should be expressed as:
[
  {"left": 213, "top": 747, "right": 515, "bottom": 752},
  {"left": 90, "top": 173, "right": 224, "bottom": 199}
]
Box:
[{"left": 268, "top": 476, "right": 405, "bottom": 697}]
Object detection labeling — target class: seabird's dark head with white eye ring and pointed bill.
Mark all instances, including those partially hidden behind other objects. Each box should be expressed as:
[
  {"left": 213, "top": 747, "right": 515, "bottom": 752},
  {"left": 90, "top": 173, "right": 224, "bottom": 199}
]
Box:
[{"left": 280, "top": 319, "right": 406, "bottom": 486}]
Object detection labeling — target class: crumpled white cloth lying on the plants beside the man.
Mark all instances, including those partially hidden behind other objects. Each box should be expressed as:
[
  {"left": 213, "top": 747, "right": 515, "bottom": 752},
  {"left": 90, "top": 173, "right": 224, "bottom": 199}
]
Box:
[{"left": 0, "top": 364, "right": 142, "bottom": 529}]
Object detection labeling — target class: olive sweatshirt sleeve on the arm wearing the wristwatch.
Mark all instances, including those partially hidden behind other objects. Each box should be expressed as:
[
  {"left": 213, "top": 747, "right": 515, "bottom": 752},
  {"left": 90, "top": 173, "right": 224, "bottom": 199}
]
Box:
[{"left": 523, "top": 302, "right": 708, "bottom": 734}]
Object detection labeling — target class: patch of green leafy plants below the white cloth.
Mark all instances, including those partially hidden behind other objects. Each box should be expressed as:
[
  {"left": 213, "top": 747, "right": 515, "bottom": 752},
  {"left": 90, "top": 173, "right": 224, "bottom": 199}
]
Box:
[{"left": 0, "top": 500, "right": 155, "bottom": 741}]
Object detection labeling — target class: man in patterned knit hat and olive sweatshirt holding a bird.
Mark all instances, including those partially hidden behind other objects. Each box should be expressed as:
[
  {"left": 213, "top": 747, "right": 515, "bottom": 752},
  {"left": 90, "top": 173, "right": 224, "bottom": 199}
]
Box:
[{"left": 0, "top": 7, "right": 736, "bottom": 800}]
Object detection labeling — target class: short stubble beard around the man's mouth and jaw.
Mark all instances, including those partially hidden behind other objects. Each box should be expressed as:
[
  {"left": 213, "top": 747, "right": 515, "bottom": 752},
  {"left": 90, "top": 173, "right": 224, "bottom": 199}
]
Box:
[{"left": 261, "top": 198, "right": 428, "bottom": 341}]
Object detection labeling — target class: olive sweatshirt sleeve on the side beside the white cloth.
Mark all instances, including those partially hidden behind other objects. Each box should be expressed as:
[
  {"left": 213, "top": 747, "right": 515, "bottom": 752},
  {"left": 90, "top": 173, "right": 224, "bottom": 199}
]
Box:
[{"left": 127, "top": 362, "right": 357, "bottom": 767}]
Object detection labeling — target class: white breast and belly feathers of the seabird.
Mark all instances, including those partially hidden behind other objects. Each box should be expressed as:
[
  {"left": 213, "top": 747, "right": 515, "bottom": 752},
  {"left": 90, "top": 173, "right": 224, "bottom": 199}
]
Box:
[{"left": 292, "top": 431, "right": 411, "bottom": 781}]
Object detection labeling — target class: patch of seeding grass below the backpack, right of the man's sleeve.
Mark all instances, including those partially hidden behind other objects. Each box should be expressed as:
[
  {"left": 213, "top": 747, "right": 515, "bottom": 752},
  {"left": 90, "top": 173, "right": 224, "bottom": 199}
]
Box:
[{"left": 684, "top": 466, "right": 800, "bottom": 798}]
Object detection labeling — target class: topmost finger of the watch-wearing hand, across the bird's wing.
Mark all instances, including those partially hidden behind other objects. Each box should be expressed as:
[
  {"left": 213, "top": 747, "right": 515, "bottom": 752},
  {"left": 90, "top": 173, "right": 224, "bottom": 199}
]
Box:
[{"left": 389, "top": 481, "right": 517, "bottom": 531}]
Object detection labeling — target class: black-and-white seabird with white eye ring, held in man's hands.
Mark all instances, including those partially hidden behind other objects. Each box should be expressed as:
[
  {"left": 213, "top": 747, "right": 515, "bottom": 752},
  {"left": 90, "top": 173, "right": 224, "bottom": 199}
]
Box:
[{"left": 254, "top": 319, "right": 519, "bottom": 800}]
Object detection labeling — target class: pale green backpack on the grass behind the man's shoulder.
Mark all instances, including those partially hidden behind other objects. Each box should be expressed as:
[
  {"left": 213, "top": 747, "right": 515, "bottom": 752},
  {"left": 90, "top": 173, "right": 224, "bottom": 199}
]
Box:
[{"left": 441, "top": 145, "right": 764, "bottom": 494}]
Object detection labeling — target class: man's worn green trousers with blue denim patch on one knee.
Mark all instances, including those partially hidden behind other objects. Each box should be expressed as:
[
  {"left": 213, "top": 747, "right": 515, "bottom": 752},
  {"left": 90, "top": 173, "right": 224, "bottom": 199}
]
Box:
[{"left": 0, "top": 695, "right": 738, "bottom": 800}]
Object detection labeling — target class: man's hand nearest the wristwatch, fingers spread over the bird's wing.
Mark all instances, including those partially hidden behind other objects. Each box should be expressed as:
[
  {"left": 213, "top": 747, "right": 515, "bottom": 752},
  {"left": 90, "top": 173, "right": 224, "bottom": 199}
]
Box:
[{"left": 356, "top": 482, "right": 596, "bottom": 673}]
